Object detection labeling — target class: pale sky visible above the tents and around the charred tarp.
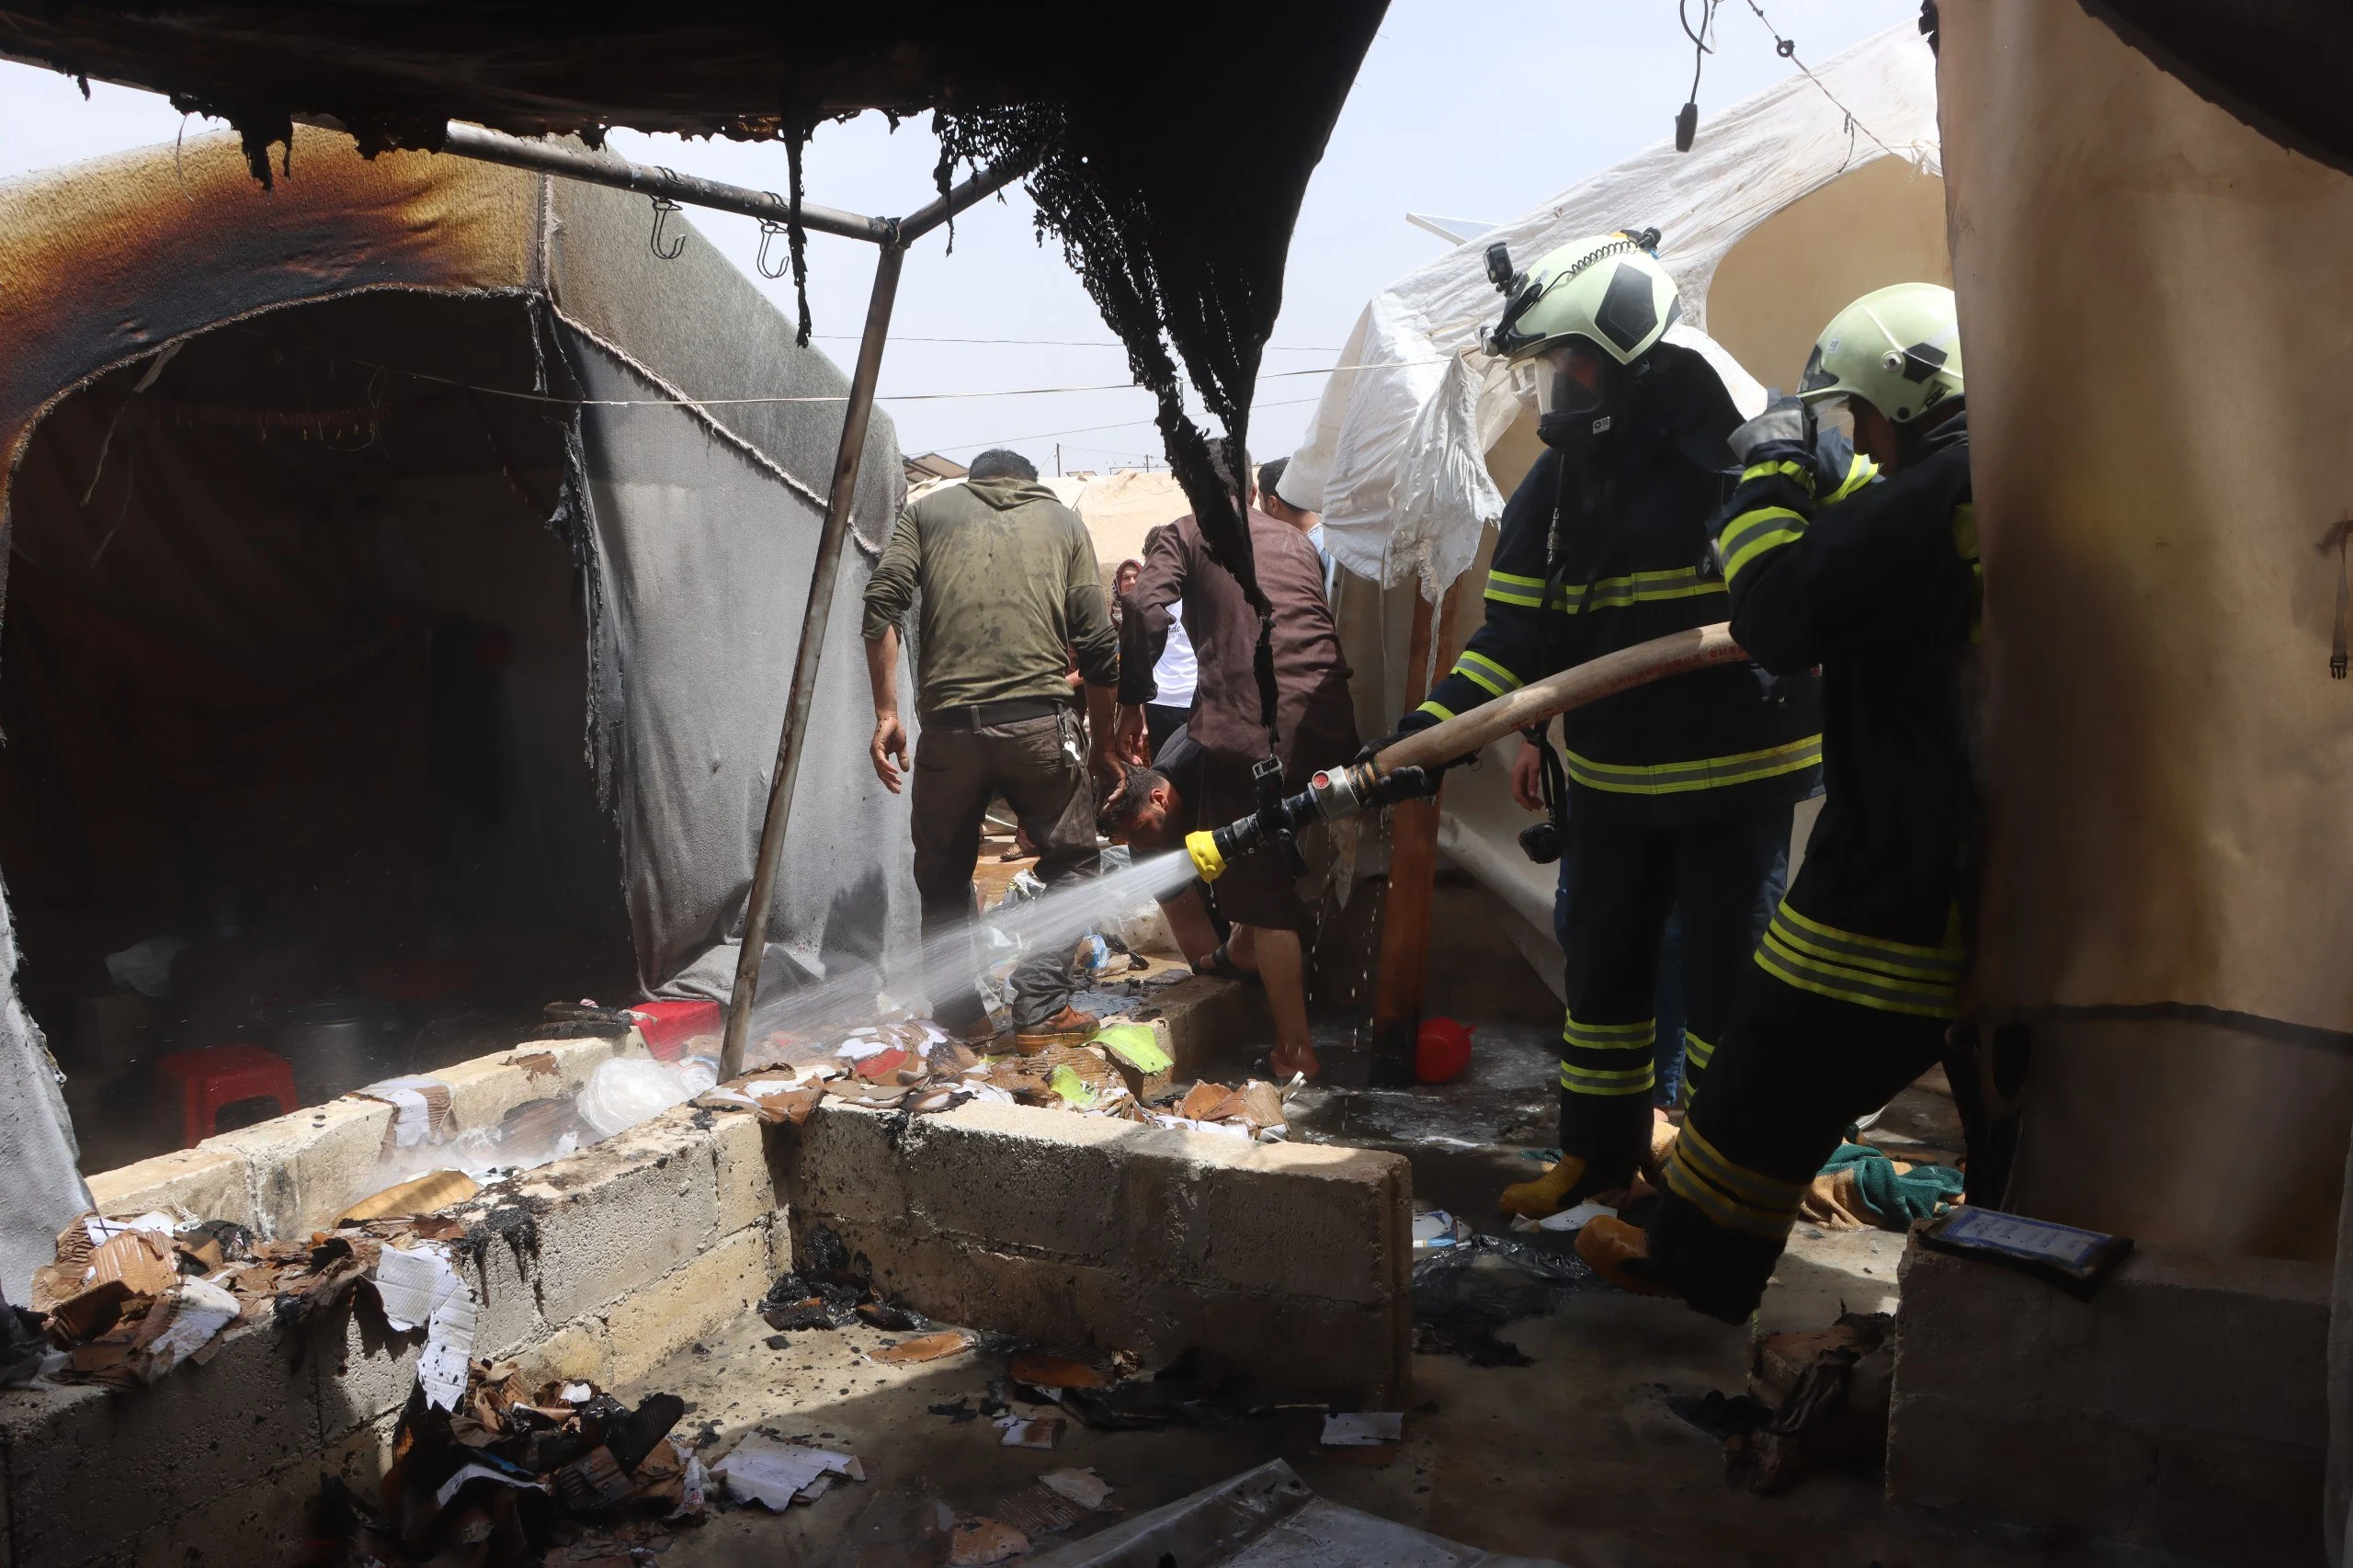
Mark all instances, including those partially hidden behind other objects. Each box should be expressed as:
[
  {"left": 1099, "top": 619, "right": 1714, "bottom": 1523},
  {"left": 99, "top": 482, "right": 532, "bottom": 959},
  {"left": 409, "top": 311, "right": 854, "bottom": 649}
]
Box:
[{"left": 0, "top": 0, "right": 1920, "bottom": 471}]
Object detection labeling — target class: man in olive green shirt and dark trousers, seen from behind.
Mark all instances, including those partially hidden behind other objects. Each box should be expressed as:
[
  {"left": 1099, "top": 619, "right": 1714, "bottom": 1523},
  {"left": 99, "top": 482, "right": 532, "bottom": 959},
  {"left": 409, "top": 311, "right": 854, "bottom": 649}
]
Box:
[{"left": 866, "top": 449, "right": 1120, "bottom": 1050}]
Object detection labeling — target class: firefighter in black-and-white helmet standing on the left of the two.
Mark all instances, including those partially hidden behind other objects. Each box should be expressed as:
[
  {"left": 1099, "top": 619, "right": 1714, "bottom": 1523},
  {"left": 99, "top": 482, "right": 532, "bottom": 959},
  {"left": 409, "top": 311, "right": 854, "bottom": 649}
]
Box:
[{"left": 1400, "top": 231, "right": 1852, "bottom": 1215}]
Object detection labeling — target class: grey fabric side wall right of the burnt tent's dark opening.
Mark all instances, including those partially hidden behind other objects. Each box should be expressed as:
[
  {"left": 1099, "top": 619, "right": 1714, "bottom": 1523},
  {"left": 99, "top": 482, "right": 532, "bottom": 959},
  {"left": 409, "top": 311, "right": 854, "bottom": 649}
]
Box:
[{"left": 548, "top": 181, "right": 917, "bottom": 1001}]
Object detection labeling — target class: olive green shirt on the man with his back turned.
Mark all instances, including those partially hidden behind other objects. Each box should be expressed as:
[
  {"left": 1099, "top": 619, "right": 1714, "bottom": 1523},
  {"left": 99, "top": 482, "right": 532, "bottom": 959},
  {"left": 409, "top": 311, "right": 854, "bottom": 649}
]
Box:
[{"left": 866, "top": 478, "right": 1120, "bottom": 713}]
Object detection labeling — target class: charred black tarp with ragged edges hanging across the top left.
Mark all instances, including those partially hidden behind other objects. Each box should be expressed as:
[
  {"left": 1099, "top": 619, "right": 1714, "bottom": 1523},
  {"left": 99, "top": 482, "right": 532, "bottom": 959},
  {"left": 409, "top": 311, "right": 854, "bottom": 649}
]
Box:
[{"left": 0, "top": 0, "right": 1386, "bottom": 677}]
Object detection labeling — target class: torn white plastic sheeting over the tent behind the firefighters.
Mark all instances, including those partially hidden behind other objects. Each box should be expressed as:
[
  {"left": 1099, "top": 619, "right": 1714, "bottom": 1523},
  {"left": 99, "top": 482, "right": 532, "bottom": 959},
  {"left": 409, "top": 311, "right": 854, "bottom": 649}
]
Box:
[{"left": 1282, "top": 26, "right": 1941, "bottom": 598}]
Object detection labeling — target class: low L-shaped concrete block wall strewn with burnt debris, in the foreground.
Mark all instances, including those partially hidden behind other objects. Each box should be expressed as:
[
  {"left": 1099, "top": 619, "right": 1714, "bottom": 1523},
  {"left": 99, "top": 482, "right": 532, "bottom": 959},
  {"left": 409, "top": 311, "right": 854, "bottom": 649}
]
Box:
[{"left": 0, "top": 1107, "right": 1412, "bottom": 1568}]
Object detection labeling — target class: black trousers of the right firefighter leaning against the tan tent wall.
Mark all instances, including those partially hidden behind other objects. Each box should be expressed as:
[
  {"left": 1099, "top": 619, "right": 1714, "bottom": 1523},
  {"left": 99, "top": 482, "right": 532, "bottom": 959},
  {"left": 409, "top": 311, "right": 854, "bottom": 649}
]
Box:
[{"left": 1650, "top": 970, "right": 1950, "bottom": 1321}]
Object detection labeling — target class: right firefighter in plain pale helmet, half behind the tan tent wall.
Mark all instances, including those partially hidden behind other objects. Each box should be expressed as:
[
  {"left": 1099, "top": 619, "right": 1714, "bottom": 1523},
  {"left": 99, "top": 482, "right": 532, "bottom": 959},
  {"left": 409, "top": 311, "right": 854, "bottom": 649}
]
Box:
[{"left": 1576, "top": 282, "right": 1979, "bottom": 1324}]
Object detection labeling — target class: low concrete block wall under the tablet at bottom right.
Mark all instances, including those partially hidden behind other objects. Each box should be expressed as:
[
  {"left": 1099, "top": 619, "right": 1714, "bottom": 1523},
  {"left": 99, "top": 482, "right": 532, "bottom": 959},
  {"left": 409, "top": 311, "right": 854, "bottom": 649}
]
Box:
[{"left": 1887, "top": 1245, "right": 2329, "bottom": 1568}]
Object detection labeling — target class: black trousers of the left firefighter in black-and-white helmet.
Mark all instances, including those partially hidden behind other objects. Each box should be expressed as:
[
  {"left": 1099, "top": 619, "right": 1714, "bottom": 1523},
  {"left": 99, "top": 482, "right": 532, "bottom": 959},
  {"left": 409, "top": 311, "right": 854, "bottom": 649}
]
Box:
[{"left": 1560, "top": 796, "right": 1793, "bottom": 1187}]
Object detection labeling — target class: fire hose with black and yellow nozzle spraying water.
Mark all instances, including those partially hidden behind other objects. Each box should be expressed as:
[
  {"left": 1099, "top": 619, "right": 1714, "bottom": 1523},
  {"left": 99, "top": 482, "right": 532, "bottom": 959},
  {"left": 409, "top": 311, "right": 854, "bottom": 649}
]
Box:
[{"left": 1184, "top": 621, "right": 1748, "bottom": 883}]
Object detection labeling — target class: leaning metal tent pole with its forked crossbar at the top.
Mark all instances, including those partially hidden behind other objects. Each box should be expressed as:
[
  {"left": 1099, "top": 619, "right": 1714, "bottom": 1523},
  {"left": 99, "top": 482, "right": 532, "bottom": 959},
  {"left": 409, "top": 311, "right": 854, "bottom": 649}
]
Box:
[{"left": 388, "top": 122, "right": 1029, "bottom": 1081}]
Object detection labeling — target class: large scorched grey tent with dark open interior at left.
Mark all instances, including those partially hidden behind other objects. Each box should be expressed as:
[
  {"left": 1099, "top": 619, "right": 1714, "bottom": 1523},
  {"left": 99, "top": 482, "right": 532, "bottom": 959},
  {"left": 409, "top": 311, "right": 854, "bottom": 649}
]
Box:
[{"left": 0, "top": 131, "right": 917, "bottom": 1292}]
